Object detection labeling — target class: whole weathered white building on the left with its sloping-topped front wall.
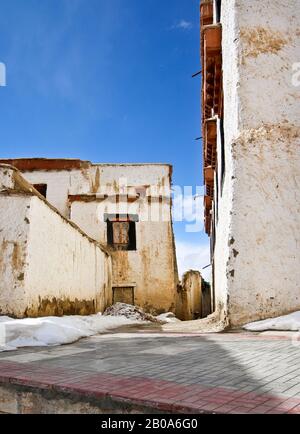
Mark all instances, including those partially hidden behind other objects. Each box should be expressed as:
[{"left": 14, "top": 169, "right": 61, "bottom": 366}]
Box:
[{"left": 0, "top": 159, "right": 179, "bottom": 317}]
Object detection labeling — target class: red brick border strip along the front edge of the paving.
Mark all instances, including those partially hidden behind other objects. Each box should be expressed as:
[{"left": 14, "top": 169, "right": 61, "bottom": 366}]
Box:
[{"left": 0, "top": 361, "right": 300, "bottom": 414}]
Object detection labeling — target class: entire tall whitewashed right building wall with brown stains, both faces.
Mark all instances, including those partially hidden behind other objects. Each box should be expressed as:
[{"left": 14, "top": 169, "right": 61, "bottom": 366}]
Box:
[{"left": 215, "top": 0, "right": 300, "bottom": 325}]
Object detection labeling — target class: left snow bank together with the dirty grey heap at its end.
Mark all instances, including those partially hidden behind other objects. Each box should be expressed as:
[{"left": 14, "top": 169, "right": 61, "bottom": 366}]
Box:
[{"left": 0, "top": 303, "right": 180, "bottom": 352}]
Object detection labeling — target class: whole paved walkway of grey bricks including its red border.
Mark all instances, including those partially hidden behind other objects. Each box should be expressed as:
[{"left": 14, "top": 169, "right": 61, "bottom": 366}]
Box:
[{"left": 0, "top": 330, "right": 300, "bottom": 414}]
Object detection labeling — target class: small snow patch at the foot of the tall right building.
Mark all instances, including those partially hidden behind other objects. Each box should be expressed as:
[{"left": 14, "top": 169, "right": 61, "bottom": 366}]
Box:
[{"left": 243, "top": 311, "right": 300, "bottom": 332}]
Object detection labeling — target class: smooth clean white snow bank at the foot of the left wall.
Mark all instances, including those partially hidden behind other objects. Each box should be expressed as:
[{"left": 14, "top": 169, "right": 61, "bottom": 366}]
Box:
[{"left": 0, "top": 314, "right": 142, "bottom": 351}]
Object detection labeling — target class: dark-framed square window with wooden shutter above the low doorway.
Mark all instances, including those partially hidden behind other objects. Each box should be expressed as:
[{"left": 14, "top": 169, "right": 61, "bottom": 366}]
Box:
[{"left": 104, "top": 214, "right": 138, "bottom": 251}]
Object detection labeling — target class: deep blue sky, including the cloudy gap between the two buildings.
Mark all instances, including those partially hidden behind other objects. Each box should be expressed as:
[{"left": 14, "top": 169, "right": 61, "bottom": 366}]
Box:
[{"left": 0, "top": 0, "right": 209, "bottom": 278}]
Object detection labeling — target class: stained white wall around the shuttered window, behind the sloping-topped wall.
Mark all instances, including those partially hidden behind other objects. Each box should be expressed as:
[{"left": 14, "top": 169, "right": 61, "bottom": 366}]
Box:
[{"left": 5, "top": 164, "right": 178, "bottom": 312}]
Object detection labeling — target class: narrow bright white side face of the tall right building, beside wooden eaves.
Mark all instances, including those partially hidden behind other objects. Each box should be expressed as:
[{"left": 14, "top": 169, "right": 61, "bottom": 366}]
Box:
[{"left": 214, "top": 0, "right": 239, "bottom": 322}]
